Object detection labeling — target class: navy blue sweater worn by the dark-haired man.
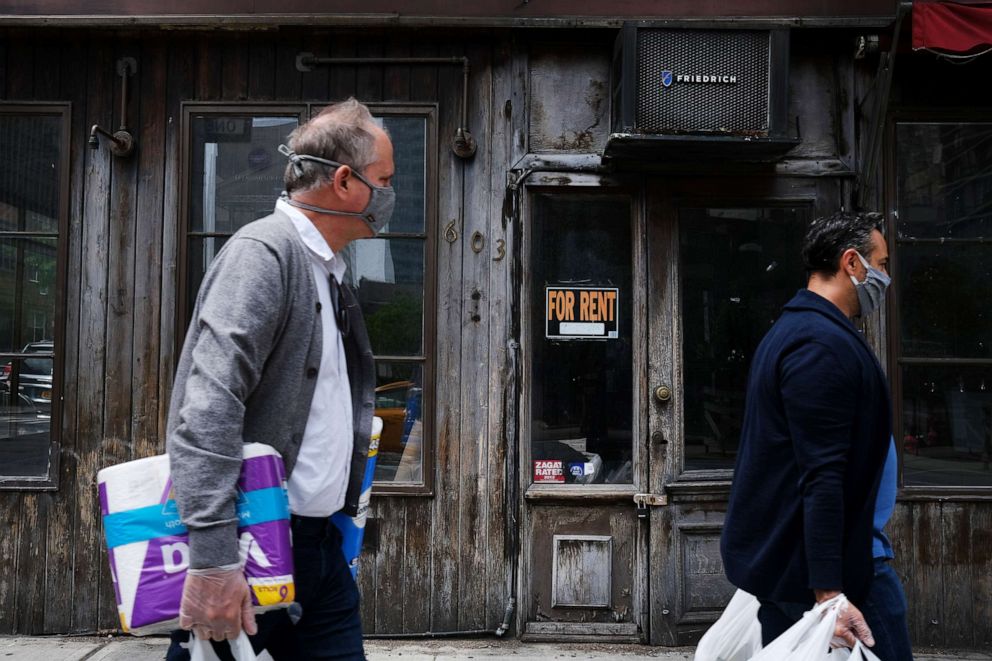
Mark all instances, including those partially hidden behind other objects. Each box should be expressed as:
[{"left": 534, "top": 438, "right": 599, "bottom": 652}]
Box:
[{"left": 720, "top": 289, "right": 892, "bottom": 603}]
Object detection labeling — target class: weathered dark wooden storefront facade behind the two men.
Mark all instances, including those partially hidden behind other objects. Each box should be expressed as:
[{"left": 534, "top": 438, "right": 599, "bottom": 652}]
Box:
[{"left": 0, "top": 2, "right": 992, "bottom": 648}]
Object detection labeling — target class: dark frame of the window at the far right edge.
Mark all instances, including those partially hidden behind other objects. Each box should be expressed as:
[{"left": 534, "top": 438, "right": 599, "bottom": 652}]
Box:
[{"left": 882, "top": 107, "right": 992, "bottom": 502}]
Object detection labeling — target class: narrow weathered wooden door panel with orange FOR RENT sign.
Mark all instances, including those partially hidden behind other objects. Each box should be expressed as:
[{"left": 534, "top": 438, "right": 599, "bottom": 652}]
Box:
[{"left": 520, "top": 173, "right": 649, "bottom": 642}]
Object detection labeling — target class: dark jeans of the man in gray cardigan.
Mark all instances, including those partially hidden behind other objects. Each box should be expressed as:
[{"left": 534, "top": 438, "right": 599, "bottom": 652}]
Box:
[{"left": 165, "top": 516, "right": 365, "bottom": 661}]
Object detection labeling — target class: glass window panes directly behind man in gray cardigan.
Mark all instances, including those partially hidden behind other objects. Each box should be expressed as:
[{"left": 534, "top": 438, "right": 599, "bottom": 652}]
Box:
[{"left": 186, "top": 105, "right": 434, "bottom": 492}]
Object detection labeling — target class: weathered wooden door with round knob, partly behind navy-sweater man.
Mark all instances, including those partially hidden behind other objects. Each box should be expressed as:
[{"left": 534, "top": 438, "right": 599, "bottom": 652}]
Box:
[{"left": 646, "top": 176, "right": 842, "bottom": 645}]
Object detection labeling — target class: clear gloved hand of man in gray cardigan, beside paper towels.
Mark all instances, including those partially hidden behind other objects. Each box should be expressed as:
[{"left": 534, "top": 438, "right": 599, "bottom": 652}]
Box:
[{"left": 179, "top": 565, "right": 257, "bottom": 641}]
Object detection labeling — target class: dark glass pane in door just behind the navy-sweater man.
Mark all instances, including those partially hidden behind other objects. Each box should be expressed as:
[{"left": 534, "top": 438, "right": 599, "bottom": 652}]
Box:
[{"left": 679, "top": 208, "right": 808, "bottom": 470}]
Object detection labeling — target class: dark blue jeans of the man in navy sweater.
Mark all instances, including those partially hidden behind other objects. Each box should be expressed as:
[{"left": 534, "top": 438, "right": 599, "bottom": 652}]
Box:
[{"left": 758, "top": 558, "right": 913, "bottom": 661}]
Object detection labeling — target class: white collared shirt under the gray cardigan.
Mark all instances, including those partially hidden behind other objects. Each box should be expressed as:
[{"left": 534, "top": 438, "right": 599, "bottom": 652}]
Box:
[{"left": 276, "top": 200, "right": 355, "bottom": 517}]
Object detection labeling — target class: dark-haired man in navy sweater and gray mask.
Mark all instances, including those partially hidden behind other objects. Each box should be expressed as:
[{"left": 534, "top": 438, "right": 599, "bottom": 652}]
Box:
[{"left": 721, "top": 213, "right": 912, "bottom": 660}]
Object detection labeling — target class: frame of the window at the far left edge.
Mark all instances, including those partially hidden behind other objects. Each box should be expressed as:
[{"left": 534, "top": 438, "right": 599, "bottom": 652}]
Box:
[{"left": 0, "top": 101, "right": 72, "bottom": 491}]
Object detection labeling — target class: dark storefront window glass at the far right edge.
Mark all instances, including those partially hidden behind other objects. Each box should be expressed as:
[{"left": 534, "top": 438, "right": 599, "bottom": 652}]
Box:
[{"left": 893, "top": 122, "right": 992, "bottom": 486}]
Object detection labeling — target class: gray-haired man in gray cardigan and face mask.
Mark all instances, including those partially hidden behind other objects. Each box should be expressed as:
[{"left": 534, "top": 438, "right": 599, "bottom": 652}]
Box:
[{"left": 166, "top": 99, "right": 394, "bottom": 661}]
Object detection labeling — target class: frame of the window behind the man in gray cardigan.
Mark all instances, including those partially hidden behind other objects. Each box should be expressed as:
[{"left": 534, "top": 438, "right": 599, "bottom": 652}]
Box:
[{"left": 174, "top": 100, "right": 438, "bottom": 496}]
